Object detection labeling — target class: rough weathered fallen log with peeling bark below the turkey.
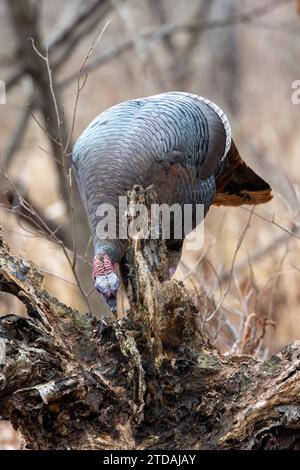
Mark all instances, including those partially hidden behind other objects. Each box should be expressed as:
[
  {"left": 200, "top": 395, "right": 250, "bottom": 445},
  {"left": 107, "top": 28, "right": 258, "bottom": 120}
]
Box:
[{"left": 0, "top": 188, "right": 300, "bottom": 449}]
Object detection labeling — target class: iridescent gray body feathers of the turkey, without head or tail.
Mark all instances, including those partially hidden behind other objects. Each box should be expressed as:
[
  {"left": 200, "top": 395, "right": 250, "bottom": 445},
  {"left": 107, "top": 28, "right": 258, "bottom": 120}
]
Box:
[{"left": 72, "top": 92, "right": 231, "bottom": 261}]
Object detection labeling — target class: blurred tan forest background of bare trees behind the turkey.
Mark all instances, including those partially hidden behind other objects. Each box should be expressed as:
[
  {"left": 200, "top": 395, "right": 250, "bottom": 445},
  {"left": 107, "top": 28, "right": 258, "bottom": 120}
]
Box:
[{"left": 0, "top": 0, "right": 300, "bottom": 449}]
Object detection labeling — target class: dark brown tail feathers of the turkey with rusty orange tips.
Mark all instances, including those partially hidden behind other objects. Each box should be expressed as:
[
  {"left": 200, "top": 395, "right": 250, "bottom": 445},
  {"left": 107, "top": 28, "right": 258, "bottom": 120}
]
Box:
[{"left": 213, "top": 141, "right": 272, "bottom": 206}]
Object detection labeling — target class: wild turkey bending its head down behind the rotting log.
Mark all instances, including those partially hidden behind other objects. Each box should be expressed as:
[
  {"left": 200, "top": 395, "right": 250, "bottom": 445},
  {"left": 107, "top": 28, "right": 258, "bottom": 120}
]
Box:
[{"left": 72, "top": 92, "right": 272, "bottom": 311}]
